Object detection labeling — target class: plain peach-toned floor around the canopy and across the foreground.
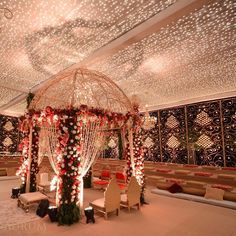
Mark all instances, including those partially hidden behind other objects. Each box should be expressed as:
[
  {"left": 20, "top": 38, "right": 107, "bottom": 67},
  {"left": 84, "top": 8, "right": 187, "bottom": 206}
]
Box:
[{"left": 0, "top": 180, "right": 236, "bottom": 236}]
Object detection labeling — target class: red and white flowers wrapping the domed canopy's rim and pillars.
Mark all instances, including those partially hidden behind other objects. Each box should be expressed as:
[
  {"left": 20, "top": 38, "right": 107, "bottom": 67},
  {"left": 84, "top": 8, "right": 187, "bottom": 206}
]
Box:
[{"left": 17, "top": 105, "right": 143, "bottom": 225}]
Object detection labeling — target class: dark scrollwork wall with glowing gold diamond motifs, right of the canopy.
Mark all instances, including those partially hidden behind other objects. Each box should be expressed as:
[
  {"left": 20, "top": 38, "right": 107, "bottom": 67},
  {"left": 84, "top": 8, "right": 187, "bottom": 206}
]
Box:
[{"left": 144, "top": 97, "right": 236, "bottom": 166}]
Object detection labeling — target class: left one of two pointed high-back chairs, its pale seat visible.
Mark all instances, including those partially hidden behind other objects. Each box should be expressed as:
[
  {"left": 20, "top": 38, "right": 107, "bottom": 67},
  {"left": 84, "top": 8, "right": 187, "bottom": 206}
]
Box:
[{"left": 89, "top": 178, "right": 120, "bottom": 219}]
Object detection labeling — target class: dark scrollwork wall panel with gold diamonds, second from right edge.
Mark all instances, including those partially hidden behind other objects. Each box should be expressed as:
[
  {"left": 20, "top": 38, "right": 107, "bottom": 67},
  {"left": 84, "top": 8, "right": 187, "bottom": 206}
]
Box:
[{"left": 187, "top": 101, "right": 224, "bottom": 166}]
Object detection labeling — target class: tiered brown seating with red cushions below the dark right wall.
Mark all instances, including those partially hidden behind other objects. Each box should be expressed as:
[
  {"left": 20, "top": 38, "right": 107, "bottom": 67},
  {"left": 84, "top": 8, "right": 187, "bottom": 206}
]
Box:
[{"left": 145, "top": 162, "right": 236, "bottom": 201}]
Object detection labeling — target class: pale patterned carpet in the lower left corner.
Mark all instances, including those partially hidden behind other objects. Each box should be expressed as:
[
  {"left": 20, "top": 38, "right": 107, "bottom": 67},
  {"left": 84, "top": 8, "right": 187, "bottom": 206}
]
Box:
[{"left": 0, "top": 199, "right": 41, "bottom": 230}]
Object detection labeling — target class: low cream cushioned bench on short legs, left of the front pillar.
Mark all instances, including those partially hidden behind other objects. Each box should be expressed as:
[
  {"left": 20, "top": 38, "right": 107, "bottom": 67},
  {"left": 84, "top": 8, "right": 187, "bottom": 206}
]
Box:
[{"left": 18, "top": 192, "right": 48, "bottom": 211}]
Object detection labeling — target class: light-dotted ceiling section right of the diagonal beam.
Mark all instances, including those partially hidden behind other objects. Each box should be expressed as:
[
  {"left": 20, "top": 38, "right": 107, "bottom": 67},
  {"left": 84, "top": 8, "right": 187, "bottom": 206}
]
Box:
[{"left": 91, "top": 0, "right": 236, "bottom": 106}]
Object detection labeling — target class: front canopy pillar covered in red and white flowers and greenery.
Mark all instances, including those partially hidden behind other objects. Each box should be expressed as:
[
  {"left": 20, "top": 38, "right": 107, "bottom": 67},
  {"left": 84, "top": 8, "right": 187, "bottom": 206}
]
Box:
[{"left": 57, "top": 110, "right": 80, "bottom": 225}]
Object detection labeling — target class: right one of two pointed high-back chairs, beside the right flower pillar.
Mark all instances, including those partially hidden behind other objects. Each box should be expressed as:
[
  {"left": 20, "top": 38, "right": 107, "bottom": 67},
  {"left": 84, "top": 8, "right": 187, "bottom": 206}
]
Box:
[{"left": 120, "top": 176, "right": 141, "bottom": 212}]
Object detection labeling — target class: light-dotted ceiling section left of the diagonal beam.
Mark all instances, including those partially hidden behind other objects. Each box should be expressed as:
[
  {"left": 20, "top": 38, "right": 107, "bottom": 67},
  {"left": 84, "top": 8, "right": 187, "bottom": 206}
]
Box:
[{"left": 0, "top": 0, "right": 173, "bottom": 106}]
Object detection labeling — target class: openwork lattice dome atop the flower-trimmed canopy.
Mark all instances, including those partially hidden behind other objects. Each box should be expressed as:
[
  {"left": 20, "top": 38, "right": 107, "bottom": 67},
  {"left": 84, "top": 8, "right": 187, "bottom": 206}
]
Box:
[{"left": 29, "top": 68, "right": 132, "bottom": 113}]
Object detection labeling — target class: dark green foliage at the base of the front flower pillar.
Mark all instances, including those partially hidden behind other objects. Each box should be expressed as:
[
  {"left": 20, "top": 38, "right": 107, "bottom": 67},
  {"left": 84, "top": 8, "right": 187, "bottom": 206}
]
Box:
[{"left": 58, "top": 202, "right": 80, "bottom": 225}]
